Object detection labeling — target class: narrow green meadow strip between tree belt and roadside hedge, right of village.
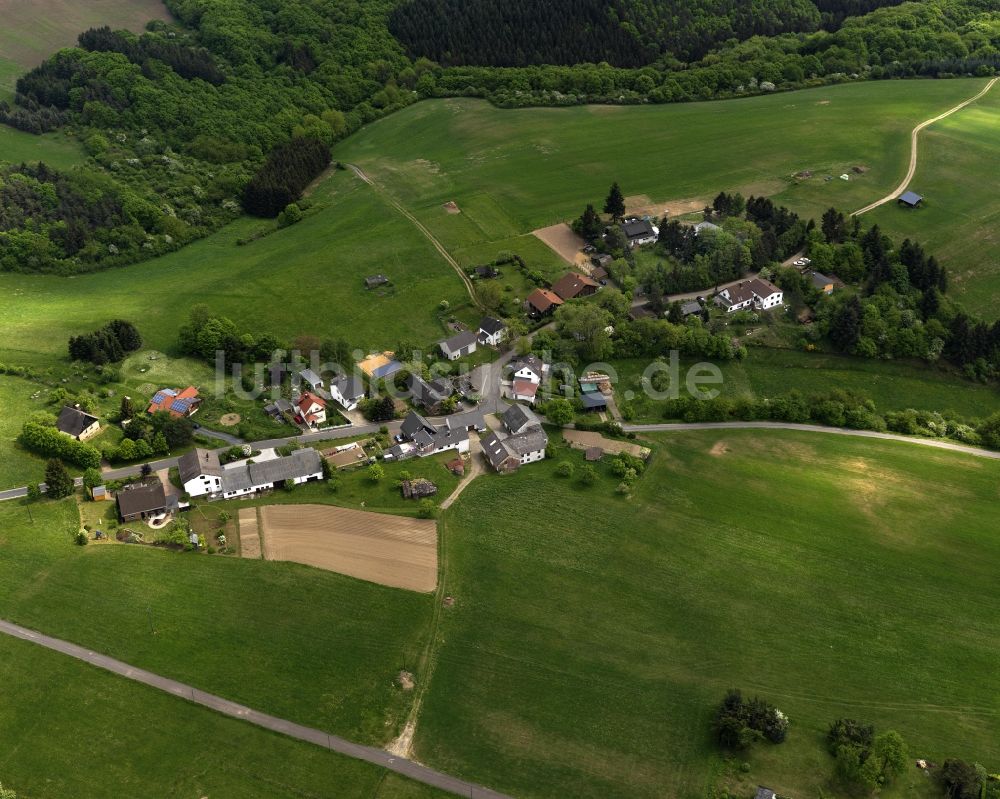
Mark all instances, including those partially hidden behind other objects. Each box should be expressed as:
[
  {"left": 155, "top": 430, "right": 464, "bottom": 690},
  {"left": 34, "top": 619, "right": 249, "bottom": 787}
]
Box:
[{"left": 613, "top": 347, "right": 1000, "bottom": 421}]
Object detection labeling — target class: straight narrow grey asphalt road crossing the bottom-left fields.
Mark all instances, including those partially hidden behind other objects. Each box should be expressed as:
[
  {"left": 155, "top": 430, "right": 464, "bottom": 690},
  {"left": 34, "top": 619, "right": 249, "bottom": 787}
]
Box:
[{"left": 0, "top": 620, "right": 510, "bottom": 799}]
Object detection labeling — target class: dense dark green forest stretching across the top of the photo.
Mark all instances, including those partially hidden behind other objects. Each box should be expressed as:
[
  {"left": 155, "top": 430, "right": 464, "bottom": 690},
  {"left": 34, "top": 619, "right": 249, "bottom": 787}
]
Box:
[{"left": 0, "top": 0, "right": 1000, "bottom": 274}]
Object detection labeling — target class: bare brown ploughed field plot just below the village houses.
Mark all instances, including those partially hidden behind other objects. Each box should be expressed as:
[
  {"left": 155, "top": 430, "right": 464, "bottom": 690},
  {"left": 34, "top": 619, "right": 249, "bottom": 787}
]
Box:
[{"left": 260, "top": 505, "right": 437, "bottom": 592}]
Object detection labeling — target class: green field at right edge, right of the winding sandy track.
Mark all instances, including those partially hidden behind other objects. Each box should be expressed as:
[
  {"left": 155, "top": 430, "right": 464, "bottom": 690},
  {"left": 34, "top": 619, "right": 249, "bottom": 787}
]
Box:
[{"left": 868, "top": 85, "right": 1000, "bottom": 320}]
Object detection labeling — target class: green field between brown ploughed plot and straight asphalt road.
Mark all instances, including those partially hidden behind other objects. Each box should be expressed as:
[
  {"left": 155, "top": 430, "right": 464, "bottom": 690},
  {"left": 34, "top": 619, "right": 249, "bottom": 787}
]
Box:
[{"left": 0, "top": 499, "right": 432, "bottom": 752}]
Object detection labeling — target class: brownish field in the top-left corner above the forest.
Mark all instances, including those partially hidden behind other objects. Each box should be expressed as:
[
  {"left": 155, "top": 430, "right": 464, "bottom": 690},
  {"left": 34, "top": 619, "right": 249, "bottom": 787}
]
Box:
[{"left": 0, "top": 0, "right": 170, "bottom": 71}]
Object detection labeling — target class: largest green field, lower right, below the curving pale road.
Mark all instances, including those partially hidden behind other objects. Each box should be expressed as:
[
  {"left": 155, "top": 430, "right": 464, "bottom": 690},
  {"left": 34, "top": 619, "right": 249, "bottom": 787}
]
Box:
[{"left": 416, "top": 431, "right": 1000, "bottom": 799}]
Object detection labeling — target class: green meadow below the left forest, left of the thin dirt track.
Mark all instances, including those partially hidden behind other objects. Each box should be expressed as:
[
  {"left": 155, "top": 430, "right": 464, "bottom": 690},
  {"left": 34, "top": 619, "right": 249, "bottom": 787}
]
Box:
[{"left": 0, "top": 172, "right": 467, "bottom": 365}]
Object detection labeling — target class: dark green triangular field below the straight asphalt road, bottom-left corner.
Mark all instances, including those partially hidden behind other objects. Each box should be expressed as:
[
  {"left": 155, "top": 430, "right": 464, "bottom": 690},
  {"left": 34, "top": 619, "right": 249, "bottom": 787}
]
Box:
[{"left": 0, "top": 636, "right": 447, "bottom": 799}]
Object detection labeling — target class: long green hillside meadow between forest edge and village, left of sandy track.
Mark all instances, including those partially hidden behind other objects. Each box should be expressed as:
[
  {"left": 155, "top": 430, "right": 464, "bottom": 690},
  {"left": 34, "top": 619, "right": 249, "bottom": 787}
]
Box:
[{"left": 334, "top": 80, "right": 984, "bottom": 249}]
